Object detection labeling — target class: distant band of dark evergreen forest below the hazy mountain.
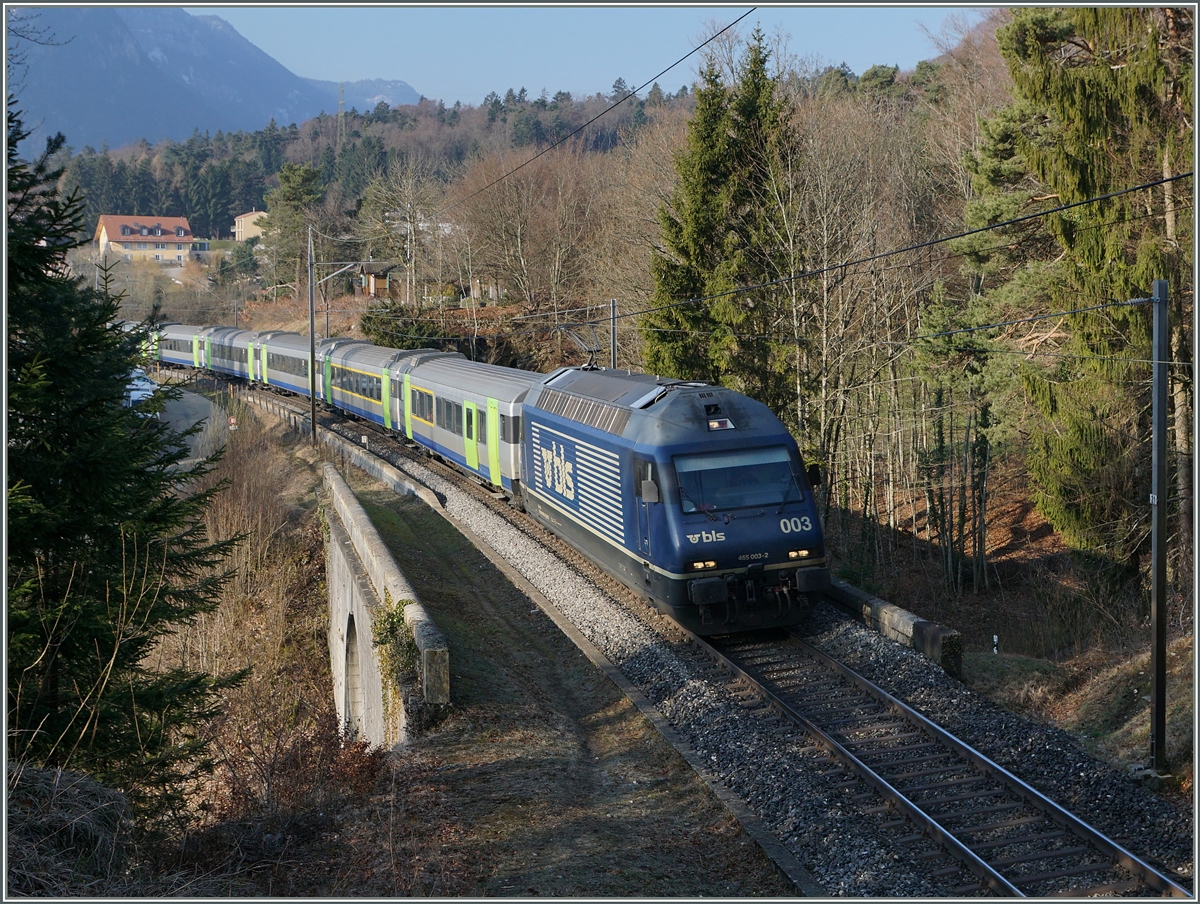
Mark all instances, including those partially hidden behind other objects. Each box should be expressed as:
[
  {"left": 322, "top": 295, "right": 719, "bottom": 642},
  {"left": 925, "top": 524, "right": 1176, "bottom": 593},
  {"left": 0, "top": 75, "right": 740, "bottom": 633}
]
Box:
[{"left": 59, "top": 89, "right": 689, "bottom": 247}]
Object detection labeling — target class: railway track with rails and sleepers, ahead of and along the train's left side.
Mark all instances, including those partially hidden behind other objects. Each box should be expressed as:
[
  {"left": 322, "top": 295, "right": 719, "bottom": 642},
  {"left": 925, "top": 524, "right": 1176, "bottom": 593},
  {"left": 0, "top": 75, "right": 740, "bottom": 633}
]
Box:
[{"left": 241, "top": 386, "right": 1192, "bottom": 898}]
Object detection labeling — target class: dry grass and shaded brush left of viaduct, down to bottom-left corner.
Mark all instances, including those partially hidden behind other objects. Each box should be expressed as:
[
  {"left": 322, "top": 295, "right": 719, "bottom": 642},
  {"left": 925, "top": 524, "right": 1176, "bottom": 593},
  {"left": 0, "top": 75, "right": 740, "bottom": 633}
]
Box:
[{"left": 8, "top": 398, "right": 383, "bottom": 897}]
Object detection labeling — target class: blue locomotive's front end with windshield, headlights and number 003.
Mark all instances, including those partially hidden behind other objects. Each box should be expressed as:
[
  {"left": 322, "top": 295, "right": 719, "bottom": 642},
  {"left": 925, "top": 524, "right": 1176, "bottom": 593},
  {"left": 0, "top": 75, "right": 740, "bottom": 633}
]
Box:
[{"left": 634, "top": 387, "right": 829, "bottom": 634}]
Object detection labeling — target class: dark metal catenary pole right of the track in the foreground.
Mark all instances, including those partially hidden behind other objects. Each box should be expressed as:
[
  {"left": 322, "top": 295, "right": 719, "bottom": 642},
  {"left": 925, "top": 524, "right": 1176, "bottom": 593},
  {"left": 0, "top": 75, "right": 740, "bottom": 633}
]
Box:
[{"left": 1150, "top": 280, "right": 1169, "bottom": 772}]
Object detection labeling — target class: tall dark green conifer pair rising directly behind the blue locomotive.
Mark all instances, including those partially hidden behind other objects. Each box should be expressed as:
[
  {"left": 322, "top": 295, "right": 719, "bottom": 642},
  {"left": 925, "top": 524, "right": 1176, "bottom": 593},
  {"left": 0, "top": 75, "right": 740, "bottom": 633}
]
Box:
[{"left": 641, "top": 31, "right": 790, "bottom": 412}]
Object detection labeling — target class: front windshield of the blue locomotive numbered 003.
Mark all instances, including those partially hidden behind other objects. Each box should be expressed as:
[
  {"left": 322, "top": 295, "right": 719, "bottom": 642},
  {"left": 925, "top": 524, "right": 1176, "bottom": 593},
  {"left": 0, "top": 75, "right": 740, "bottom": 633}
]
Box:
[{"left": 674, "top": 445, "right": 802, "bottom": 514}]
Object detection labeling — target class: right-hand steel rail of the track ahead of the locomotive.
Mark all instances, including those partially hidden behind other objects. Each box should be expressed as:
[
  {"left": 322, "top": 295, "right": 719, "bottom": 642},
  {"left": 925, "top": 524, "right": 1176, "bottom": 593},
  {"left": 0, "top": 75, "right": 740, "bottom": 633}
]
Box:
[{"left": 787, "top": 629, "right": 1192, "bottom": 898}]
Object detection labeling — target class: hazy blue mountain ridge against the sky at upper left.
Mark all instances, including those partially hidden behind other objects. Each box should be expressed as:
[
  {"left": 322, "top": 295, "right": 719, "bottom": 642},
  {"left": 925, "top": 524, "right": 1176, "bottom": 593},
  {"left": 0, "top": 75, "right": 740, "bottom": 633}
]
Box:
[{"left": 10, "top": 6, "right": 420, "bottom": 149}]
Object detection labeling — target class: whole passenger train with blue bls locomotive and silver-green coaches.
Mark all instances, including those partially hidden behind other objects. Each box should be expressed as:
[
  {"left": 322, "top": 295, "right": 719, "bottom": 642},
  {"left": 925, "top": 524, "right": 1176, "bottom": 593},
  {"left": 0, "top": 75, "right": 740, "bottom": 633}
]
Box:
[{"left": 149, "top": 323, "right": 829, "bottom": 635}]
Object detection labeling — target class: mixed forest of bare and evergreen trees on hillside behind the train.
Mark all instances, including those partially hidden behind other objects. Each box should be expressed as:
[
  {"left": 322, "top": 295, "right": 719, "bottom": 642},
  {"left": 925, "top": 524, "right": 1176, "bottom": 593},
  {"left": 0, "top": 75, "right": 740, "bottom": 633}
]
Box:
[{"left": 64, "top": 8, "right": 1194, "bottom": 654}]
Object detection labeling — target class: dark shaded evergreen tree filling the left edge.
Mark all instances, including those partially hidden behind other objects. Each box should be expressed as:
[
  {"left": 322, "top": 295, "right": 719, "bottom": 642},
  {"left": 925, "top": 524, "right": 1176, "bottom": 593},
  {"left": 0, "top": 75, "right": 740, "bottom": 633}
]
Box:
[{"left": 6, "top": 98, "right": 240, "bottom": 801}]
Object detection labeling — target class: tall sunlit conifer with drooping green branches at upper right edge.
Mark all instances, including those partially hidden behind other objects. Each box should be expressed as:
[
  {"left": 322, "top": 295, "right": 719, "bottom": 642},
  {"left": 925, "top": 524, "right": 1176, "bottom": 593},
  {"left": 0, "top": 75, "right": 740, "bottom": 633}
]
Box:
[{"left": 962, "top": 8, "right": 1193, "bottom": 567}]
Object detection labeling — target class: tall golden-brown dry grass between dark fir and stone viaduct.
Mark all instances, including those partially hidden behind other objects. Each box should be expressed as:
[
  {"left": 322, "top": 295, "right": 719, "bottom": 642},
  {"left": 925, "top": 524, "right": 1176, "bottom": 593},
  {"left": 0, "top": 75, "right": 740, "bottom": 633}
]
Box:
[{"left": 166, "top": 400, "right": 383, "bottom": 891}]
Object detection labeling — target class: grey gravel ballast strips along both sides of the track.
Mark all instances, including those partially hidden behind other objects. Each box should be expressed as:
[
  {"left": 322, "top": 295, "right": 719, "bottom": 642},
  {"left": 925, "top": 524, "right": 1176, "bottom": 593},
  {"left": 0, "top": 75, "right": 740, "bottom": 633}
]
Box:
[{"left": 343, "top": 427, "right": 1194, "bottom": 897}]
